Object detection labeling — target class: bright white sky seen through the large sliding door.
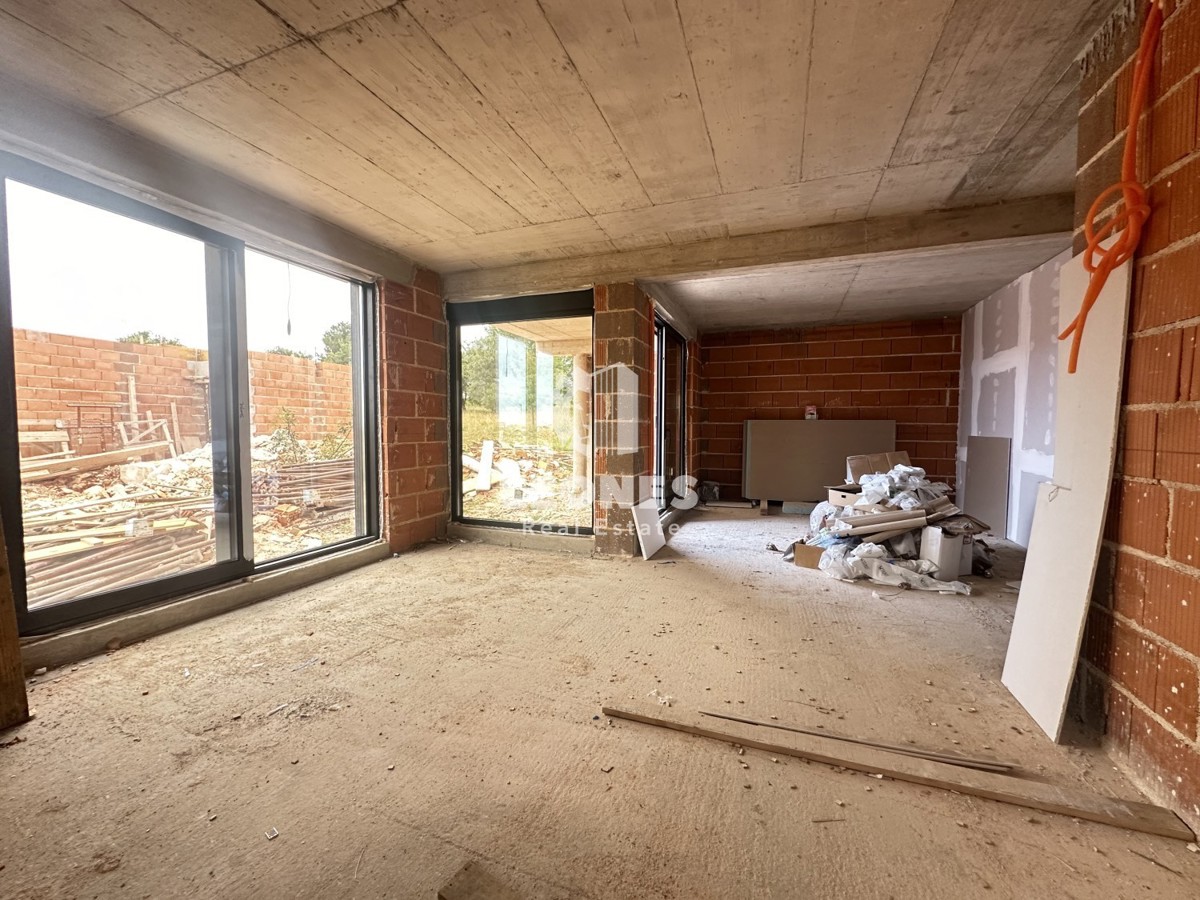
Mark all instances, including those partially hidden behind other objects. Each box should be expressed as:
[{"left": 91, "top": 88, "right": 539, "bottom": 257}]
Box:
[{"left": 6, "top": 180, "right": 352, "bottom": 353}]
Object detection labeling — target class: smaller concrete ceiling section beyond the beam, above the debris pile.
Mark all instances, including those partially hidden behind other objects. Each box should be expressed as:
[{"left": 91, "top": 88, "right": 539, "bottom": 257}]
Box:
[{"left": 643, "top": 235, "right": 1064, "bottom": 331}]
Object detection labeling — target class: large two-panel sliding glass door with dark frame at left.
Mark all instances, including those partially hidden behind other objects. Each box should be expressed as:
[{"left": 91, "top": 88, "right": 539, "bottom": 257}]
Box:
[{"left": 0, "top": 154, "right": 377, "bottom": 632}]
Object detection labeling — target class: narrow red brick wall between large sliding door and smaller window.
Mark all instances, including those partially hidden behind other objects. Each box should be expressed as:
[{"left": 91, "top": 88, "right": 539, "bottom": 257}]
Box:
[{"left": 379, "top": 269, "right": 450, "bottom": 552}]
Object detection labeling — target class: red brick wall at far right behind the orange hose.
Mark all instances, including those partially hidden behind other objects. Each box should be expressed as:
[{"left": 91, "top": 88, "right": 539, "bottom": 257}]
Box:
[{"left": 1076, "top": 0, "right": 1200, "bottom": 826}]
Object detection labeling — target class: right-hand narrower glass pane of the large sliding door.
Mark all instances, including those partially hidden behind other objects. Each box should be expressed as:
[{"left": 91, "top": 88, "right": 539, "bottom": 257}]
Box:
[{"left": 246, "top": 250, "right": 365, "bottom": 563}]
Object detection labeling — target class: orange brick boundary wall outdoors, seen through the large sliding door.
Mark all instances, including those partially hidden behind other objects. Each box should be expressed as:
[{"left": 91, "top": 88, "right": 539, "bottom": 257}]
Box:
[{"left": 13, "top": 329, "right": 352, "bottom": 454}]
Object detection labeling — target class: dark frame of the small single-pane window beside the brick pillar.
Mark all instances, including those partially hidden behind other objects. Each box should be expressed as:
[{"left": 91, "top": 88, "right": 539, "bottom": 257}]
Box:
[{"left": 446, "top": 290, "right": 595, "bottom": 536}]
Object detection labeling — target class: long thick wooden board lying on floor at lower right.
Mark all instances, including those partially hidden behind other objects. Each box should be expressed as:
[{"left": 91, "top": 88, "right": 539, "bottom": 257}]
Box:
[{"left": 602, "top": 706, "right": 1195, "bottom": 841}]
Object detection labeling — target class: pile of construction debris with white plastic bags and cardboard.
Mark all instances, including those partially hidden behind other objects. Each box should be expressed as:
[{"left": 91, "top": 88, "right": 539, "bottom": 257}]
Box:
[{"left": 785, "top": 454, "right": 992, "bottom": 594}]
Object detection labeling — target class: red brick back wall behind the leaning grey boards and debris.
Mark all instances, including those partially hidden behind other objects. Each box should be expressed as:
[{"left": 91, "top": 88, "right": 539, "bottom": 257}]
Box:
[{"left": 698, "top": 317, "right": 961, "bottom": 497}]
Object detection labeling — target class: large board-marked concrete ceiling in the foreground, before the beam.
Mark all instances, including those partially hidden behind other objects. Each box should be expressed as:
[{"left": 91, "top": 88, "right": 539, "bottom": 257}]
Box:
[{"left": 0, "top": 0, "right": 1114, "bottom": 282}]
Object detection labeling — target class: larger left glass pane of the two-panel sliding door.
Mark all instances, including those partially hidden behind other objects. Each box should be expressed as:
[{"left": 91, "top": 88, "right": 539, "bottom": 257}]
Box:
[{"left": 6, "top": 180, "right": 232, "bottom": 610}]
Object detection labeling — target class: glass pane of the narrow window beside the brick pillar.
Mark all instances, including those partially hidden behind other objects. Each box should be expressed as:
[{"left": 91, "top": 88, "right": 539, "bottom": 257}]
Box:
[{"left": 458, "top": 317, "right": 592, "bottom": 528}]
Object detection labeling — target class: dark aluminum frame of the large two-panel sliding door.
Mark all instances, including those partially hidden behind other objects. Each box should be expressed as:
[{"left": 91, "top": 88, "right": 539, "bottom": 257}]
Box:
[{"left": 0, "top": 151, "right": 380, "bottom": 635}]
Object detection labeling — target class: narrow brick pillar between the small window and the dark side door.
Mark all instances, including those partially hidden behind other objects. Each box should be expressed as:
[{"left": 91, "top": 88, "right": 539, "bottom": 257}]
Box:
[{"left": 593, "top": 284, "right": 654, "bottom": 556}]
